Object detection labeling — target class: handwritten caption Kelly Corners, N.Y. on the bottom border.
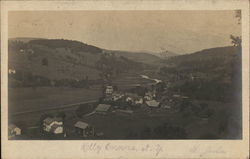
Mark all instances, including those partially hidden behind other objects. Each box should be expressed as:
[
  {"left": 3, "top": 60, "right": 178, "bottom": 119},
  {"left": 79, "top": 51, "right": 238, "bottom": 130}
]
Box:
[{"left": 81, "top": 143, "right": 163, "bottom": 156}]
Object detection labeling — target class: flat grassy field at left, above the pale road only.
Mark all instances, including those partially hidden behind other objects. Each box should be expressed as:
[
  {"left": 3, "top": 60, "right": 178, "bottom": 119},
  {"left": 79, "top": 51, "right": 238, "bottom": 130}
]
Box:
[{"left": 9, "top": 87, "right": 101, "bottom": 113}]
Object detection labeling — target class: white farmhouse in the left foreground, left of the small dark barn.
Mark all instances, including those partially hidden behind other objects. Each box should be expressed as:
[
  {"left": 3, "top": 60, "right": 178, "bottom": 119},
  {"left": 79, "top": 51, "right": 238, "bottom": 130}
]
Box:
[{"left": 43, "top": 117, "right": 63, "bottom": 134}]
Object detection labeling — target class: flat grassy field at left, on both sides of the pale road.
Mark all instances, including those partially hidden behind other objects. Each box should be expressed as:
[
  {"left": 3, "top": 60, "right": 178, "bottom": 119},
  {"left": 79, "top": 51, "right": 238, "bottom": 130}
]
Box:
[{"left": 8, "top": 87, "right": 101, "bottom": 127}]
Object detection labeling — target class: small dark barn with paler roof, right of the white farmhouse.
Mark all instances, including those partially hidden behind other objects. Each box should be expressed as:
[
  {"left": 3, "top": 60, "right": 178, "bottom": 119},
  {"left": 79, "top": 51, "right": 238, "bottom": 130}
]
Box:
[{"left": 74, "top": 121, "right": 95, "bottom": 137}]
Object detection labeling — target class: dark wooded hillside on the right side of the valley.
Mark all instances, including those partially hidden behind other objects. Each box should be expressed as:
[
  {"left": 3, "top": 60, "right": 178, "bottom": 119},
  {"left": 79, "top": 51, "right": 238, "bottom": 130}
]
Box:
[{"left": 159, "top": 46, "right": 241, "bottom": 101}]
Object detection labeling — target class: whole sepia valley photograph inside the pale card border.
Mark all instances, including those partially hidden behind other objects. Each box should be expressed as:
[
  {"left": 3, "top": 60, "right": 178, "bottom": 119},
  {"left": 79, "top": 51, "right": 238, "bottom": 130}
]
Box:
[{"left": 8, "top": 10, "right": 242, "bottom": 140}]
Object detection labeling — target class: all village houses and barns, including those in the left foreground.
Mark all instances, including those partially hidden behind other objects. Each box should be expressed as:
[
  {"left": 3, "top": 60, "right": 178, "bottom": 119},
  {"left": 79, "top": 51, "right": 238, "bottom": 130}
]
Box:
[{"left": 9, "top": 80, "right": 193, "bottom": 138}]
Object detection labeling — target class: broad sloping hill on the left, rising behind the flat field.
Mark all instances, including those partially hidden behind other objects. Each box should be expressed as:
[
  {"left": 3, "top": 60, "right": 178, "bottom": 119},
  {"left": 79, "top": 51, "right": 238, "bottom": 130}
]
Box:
[{"left": 9, "top": 38, "right": 143, "bottom": 85}]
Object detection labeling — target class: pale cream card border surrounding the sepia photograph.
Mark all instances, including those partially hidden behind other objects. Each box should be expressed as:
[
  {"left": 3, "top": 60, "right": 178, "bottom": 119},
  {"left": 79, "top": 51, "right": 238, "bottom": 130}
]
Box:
[{"left": 1, "top": 0, "right": 249, "bottom": 159}]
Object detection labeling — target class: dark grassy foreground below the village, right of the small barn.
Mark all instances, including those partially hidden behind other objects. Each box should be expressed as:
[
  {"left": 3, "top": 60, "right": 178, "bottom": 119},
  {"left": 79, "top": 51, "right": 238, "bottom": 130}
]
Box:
[{"left": 72, "top": 101, "right": 239, "bottom": 139}]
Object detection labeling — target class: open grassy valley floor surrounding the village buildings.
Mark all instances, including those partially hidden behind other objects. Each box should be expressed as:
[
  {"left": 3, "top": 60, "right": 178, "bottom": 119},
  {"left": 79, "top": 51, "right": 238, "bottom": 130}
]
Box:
[{"left": 9, "top": 71, "right": 241, "bottom": 140}]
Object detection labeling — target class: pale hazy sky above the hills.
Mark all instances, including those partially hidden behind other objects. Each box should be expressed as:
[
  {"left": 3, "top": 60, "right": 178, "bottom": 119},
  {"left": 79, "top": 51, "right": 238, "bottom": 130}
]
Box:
[{"left": 8, "top": 10, "right": 241, "bottom": 54}]
